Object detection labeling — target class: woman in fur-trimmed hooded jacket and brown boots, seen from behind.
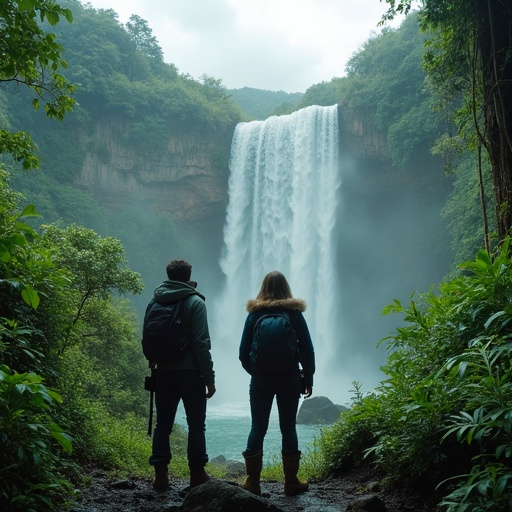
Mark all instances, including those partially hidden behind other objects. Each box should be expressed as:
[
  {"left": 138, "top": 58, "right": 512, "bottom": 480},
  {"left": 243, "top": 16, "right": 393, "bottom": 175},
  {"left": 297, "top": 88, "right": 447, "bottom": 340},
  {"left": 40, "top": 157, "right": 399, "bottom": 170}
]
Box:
[{"left": 239, "top": 271, "right": 315, "bottom": 496}]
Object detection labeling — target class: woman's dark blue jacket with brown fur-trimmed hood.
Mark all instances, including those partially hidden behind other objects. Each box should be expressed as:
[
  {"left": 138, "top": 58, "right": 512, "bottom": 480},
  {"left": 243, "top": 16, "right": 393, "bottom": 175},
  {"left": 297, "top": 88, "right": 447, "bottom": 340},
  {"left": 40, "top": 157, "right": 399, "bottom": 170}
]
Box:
[{"left": 239, "top": 298, "right": 315, "bottom": 387}]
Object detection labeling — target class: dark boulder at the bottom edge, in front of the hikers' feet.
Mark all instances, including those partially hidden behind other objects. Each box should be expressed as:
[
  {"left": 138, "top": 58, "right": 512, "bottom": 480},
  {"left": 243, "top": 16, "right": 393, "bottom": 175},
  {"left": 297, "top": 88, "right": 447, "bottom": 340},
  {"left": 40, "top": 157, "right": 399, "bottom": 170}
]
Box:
[{"left": 178, "top": 478, "right": 284, "bottom": 512}]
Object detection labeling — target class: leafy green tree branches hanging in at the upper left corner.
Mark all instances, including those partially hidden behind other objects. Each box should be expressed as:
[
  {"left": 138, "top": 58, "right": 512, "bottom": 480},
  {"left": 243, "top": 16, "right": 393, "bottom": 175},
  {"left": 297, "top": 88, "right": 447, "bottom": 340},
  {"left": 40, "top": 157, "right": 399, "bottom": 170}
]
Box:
[{"left": 0, "top": 0, "right": 75, "bottom": 168}]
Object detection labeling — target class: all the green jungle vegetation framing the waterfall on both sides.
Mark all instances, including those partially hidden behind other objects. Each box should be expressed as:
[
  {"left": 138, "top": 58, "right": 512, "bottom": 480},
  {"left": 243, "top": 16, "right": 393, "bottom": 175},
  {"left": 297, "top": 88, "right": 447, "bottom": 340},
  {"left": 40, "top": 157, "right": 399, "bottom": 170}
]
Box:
[{"left": 0, "top": 0, "right": 512, "bottom": 512}]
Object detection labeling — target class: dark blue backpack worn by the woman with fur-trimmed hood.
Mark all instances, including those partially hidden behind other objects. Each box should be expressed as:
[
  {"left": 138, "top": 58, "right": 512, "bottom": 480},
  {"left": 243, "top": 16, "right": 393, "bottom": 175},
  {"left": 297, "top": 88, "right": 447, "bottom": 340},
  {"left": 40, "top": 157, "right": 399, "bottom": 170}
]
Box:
[{"left": 250, "top": 313, "right": 299, "bottom": 372}]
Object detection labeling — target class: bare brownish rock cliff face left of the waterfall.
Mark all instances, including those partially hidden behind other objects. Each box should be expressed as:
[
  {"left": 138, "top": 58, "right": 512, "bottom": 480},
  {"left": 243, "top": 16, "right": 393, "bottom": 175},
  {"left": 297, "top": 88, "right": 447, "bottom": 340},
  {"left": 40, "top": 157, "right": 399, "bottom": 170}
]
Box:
[{"left": 77, "top": 120, "right": 234, "bottom": 230}]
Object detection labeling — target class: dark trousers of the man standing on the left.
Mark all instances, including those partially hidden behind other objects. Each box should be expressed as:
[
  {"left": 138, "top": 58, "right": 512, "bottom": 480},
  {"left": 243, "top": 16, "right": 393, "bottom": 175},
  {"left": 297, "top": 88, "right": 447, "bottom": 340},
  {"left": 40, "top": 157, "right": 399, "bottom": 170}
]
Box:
[{"left": 149, "top": 370, "right": 208, "bottom": 469}]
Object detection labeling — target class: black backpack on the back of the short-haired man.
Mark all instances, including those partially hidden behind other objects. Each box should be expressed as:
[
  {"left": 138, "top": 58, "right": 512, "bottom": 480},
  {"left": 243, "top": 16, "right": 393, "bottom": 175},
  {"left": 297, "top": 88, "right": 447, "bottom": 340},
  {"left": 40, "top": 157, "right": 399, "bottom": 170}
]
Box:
[{"left": 142, "top": 299, "right": 190, "bottom": 363}]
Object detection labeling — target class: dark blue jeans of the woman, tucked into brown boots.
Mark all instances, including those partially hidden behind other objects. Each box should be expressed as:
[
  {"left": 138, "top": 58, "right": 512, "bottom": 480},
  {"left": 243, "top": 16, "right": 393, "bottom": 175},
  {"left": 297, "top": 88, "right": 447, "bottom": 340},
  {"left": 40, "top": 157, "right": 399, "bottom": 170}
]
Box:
[{"left": 247, "top": 370, "right": 300, "bottom": 453}]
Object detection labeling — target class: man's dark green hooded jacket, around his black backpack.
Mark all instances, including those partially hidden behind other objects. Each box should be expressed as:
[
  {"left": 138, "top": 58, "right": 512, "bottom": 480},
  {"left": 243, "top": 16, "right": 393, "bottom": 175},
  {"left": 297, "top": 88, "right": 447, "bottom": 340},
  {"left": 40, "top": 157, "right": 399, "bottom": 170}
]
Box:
[{"left": 154, "top": 281, "right": 215, "bottom": 385}]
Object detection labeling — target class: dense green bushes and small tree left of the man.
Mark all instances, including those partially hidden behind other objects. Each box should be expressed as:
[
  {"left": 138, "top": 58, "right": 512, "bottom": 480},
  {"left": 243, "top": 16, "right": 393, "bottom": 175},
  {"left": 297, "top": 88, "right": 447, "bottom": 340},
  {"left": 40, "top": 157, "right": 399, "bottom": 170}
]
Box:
[{"left": 0, "top": 168, "right": 159, "bottom": 488}]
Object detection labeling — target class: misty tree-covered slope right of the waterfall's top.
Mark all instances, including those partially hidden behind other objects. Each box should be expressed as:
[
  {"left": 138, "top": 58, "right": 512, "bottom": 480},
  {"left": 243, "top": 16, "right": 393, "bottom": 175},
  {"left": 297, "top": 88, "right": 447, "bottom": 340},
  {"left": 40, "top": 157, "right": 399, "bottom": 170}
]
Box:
[{"left": 340, "top": 15, "right": 446, "bottom": 166}]
